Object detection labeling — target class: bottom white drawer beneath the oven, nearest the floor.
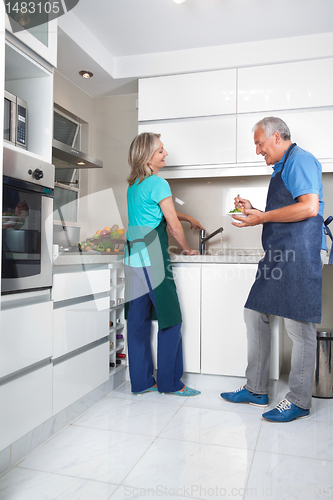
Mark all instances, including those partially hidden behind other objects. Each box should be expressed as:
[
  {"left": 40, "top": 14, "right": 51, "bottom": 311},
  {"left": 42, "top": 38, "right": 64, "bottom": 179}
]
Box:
[{"left": 0, "top": 364, "right": 52, "bottom": 450}]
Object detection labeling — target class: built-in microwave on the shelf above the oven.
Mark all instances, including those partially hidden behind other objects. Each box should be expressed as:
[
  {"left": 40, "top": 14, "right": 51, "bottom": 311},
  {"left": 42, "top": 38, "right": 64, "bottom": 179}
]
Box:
[{"left": 3, "top": 90, "right": 27, "bottom": 149}]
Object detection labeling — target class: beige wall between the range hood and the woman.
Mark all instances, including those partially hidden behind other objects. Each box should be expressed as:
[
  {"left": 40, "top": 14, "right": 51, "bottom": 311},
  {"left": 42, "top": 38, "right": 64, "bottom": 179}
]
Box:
[{"left": 54, "top": 72, "right": 138, "bottom": 240}]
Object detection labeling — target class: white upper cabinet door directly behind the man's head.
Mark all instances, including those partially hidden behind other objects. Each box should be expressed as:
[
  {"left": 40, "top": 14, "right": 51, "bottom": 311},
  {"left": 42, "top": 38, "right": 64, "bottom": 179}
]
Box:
[{"left": 237, "top": 109, "right": 333, "bottom": 165}]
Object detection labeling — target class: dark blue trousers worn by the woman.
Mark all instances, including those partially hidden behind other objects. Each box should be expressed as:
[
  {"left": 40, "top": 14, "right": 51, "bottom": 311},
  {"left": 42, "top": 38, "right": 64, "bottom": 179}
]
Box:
[{"left": 126, "top": 266, "right": 184, "bottom": 392}]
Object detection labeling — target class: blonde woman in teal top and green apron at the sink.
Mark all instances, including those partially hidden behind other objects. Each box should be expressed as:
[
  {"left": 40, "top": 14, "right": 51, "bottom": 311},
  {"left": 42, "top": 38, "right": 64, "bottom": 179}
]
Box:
[{"left": 125, "top": 132, "right": 203, "bottom": 396}]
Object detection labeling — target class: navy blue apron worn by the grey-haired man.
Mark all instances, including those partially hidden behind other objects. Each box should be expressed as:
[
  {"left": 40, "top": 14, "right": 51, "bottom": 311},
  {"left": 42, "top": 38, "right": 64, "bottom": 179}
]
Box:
[{"left": 245, "top": 144, "right": 323, "bottom": 323}]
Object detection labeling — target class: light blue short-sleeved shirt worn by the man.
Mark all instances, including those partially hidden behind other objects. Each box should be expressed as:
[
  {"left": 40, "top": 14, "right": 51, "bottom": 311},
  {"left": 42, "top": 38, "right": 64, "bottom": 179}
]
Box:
[{"left": 272, "top": 146, "right": 327, "bottom": 250}]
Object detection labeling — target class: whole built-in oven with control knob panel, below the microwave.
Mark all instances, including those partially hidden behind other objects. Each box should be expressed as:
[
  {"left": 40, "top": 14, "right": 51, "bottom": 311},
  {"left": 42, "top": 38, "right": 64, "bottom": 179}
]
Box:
[{"left": 1, "top": 146, "right": 54, "bottom": 294}]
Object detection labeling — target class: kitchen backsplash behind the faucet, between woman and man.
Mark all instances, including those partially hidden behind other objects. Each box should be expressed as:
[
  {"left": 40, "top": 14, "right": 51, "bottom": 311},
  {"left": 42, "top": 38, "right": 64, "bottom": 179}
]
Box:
[{"left": 168, "top": 173, "right": 333, "bottom": 250}]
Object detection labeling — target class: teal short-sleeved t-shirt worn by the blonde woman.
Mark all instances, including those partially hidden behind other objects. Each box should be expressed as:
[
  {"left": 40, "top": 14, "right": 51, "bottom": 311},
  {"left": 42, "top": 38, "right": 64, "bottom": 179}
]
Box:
[{"left": 124, "top": 175, "right": 172, "bottom": 267}]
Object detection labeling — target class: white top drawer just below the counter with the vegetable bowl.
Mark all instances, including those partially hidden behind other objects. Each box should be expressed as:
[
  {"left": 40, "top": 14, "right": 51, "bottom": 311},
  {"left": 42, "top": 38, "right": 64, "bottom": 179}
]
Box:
[{"left": 53, "top": 269, "right": 110, "bottom": 302}]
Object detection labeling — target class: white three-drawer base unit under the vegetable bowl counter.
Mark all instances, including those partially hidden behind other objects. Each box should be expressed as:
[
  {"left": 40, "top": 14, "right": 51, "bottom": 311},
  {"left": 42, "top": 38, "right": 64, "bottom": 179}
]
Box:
[{"left": 52, "top": 266, "right": 110, "bottom": 415}]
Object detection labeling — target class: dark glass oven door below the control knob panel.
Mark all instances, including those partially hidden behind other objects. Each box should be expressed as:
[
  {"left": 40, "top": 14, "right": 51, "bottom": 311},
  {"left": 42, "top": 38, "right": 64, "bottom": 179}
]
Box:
[{"left": 1, "top": 177, "right": 53, "bottom": 294}]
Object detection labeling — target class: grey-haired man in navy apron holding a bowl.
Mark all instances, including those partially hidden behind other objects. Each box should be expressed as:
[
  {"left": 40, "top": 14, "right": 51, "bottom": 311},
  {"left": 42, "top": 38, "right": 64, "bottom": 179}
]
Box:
[{"left": 221, "top": 117, "right": 326, "bottom": 422}]
